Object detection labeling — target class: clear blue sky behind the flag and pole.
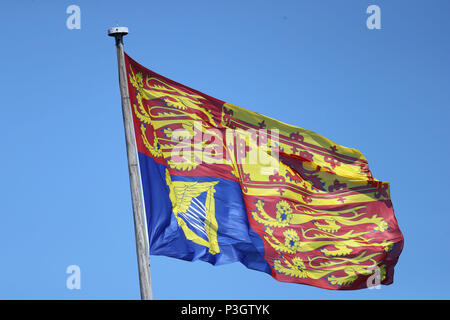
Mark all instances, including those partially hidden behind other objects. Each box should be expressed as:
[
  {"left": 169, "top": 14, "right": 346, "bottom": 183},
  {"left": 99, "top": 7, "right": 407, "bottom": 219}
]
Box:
[{"left": 0, "top": 0, "right": 450, "bottom": 299}]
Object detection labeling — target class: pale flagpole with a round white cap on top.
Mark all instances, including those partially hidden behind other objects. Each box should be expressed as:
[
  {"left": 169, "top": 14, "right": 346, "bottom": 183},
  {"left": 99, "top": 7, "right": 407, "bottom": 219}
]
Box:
[{"left": 108, "top": 27, "right": 153, "bottom": 300}]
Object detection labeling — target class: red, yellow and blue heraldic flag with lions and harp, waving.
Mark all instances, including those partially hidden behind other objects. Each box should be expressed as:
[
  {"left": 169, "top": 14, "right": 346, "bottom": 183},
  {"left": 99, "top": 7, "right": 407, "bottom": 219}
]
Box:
[{"left": 125, "top": 54, "right": 403, "bottom": 289}]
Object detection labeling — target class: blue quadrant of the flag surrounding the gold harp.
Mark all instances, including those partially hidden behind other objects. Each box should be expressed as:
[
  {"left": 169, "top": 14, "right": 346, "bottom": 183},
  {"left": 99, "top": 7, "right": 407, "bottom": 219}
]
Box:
[{"left": 139, "top": 153, "right": 271, "bottom": 274}]
